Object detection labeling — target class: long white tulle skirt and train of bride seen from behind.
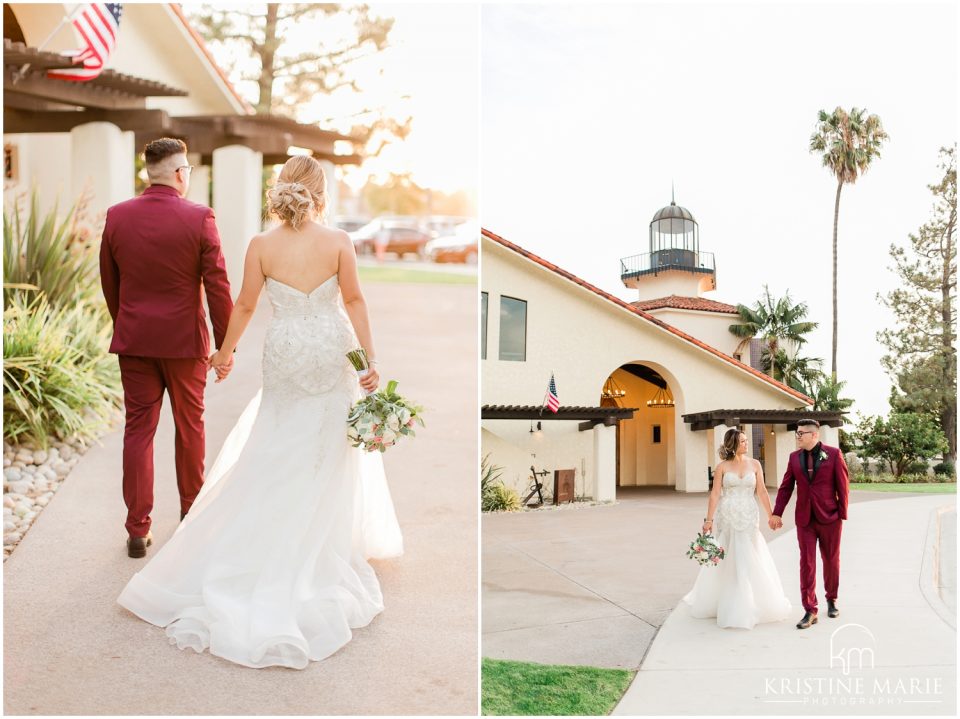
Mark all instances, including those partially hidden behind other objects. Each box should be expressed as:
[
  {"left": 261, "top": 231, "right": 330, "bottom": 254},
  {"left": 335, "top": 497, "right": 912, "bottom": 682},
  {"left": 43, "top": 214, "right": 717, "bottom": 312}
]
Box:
[{"left": 118, "top": 276, "right": 403, "bottom": 669}]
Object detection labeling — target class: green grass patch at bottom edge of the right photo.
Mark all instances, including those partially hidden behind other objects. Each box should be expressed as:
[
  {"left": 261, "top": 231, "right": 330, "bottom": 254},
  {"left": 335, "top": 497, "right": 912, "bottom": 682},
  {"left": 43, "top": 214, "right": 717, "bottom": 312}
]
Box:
[{"left": 481, "top": 658, "right": 636, "bottom": 716}]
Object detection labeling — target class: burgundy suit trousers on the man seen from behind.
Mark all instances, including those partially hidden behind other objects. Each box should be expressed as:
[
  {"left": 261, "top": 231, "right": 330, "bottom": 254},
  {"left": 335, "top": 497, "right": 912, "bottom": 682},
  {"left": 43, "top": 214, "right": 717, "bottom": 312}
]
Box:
[{"left": 120, "top": 355, "right": 207, "bottom": 537}]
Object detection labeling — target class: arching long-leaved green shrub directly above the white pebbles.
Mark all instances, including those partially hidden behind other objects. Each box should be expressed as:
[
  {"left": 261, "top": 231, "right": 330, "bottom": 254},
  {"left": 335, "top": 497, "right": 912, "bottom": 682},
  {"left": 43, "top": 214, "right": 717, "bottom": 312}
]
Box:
[{"left": 3, "top": 291, "right": 122, "bottom": 446}]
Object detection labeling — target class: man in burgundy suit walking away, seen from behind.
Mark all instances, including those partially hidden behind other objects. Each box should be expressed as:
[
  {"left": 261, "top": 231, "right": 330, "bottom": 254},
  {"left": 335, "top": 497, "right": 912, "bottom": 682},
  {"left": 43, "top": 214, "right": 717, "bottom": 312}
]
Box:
[{"left": 100, "top": 138, "right": 233, "bottom": 557}]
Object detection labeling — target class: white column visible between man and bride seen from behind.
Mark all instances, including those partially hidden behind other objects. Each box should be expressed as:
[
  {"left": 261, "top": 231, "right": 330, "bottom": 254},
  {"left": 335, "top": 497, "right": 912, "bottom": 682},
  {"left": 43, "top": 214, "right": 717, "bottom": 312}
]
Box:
[{"left": 213, "top": 145, "right": 263, "bottom": 298}]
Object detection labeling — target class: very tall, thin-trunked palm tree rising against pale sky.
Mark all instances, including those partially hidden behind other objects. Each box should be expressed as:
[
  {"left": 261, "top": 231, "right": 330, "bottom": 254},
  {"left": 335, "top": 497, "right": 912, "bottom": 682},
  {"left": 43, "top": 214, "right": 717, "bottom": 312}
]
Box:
[{"left": 810, "top": 107, "right": 888, "bottom": 381}]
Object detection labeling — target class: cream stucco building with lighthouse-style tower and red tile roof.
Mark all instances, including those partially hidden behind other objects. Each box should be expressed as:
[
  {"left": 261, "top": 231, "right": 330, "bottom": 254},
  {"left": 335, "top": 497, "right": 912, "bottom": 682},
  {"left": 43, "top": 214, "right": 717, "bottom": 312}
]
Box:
[{"left": 481, "top": 200, "right": 840, "bottom": 501}]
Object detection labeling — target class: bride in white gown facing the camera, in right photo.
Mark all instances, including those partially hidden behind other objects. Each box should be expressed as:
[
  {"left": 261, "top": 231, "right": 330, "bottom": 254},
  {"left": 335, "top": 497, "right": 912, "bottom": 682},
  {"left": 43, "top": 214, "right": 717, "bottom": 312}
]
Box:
[{"left": 683, "top": 429, "right": 791, "bottom": 629}]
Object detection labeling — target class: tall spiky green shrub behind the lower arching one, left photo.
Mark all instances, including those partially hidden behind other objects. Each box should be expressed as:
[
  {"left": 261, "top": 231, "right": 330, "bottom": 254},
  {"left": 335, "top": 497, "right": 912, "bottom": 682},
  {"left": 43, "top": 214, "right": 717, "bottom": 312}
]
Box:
[{"left": 3, "top": 190, "right": 100, "bottom": 307}]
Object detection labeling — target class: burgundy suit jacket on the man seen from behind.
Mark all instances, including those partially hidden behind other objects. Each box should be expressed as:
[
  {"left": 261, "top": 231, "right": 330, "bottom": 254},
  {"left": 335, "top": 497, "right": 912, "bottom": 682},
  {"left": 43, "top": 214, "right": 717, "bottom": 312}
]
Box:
[{"left": 100, "top": 185, "right": 233, "bottom": 358}]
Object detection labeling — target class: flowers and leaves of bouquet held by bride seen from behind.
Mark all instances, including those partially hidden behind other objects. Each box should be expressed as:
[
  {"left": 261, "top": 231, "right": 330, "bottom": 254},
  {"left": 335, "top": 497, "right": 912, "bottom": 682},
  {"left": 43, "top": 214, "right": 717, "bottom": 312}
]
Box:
[{"left": 347, "top": 380, "right": 424, "bottom": 452}]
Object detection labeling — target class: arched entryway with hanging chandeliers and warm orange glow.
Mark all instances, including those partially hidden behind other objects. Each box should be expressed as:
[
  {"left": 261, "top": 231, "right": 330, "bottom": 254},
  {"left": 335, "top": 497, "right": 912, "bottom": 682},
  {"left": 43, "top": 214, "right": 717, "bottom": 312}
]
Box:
[{"left": 600, "top": 361, "right": 683, "bottom": 492}]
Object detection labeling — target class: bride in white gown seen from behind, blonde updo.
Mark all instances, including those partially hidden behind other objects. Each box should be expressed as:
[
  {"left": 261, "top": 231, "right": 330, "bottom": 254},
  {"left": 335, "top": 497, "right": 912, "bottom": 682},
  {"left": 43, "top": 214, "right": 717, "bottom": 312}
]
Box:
[{"left": 117, "top": 156, "right": 403, "bottom": 669}]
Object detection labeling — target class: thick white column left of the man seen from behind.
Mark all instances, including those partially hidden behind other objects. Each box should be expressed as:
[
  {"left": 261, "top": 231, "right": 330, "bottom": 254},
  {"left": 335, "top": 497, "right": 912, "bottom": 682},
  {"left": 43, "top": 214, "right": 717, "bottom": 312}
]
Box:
[{"left": 71, "top": 122, "right": 136, "bottom": 219}]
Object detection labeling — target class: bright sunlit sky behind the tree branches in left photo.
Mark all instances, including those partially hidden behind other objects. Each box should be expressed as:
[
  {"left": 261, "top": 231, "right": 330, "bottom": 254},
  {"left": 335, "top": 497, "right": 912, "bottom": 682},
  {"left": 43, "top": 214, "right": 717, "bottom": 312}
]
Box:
[{"left": 185, "top": 2, "right": 480, "bottom": 201}]
